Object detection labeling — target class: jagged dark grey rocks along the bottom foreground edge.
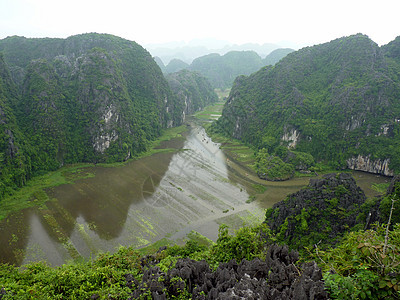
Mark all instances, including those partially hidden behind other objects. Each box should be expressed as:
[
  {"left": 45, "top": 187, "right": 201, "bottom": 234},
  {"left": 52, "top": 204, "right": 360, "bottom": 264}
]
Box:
[{"left": 126, "top": 245, "right": 328, "bottom": 300}]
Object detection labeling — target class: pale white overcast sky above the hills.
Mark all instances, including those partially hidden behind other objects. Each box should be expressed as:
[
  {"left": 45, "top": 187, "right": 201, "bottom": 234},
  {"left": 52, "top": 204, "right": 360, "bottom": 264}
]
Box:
[{"left": 0, "top": 0, "right": 400, "bottom": 46}]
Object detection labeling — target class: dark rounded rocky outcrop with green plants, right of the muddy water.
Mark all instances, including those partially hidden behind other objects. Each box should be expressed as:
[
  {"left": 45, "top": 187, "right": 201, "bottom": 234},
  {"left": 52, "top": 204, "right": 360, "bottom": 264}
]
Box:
[{"left": 266, "top": 173, "right": 366, "bottom": 247}]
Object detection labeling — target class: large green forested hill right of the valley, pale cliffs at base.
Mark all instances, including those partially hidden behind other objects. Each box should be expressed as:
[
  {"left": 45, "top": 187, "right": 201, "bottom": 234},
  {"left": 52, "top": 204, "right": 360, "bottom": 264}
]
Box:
[{"left": 217, "top": 34, "right": 400, "bottom": 175}]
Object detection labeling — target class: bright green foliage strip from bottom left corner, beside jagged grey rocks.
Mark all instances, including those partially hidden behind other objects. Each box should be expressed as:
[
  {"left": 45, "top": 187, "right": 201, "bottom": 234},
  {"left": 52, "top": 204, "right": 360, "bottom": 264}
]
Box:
[{"left": 0, "top": 225, "right": 268, "bottom": 299}]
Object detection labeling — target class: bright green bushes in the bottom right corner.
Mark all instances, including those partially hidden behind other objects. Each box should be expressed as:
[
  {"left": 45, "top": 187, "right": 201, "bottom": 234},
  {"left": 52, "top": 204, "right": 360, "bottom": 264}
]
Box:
[{"left": 313, "top": 224, "right": 400, "bottom": 299}]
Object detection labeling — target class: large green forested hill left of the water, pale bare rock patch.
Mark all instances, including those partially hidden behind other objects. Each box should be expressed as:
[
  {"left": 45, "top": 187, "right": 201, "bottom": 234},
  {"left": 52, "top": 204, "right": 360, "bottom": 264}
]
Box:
[{"left": 0, "top": 33, "right": 216, "bottom": 195}]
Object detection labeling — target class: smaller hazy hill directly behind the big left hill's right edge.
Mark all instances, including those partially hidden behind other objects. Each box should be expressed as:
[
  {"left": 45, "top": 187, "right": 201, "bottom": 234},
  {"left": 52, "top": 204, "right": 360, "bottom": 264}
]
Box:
[{"left": 166, "top": 70, "right": 218, "bottom": 122}]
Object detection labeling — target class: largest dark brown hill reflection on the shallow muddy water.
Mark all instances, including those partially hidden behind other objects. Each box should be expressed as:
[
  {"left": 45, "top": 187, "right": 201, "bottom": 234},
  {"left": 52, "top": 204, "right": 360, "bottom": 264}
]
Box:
[{"left": 52, "top": 153, "right": 172, "bottom": 240}]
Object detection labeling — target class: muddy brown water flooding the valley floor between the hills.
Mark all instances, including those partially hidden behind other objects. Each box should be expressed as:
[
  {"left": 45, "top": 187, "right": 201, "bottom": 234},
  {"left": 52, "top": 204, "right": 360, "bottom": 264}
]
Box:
[{"left": 0, "top": 125, "right": 387, "bottom": 265}]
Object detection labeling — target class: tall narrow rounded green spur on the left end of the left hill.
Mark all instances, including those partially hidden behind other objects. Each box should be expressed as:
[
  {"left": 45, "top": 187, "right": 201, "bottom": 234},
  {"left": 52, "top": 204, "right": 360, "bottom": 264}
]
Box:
[{"left": 17, "top": 60, "right": 66, "bottom": 170}]
